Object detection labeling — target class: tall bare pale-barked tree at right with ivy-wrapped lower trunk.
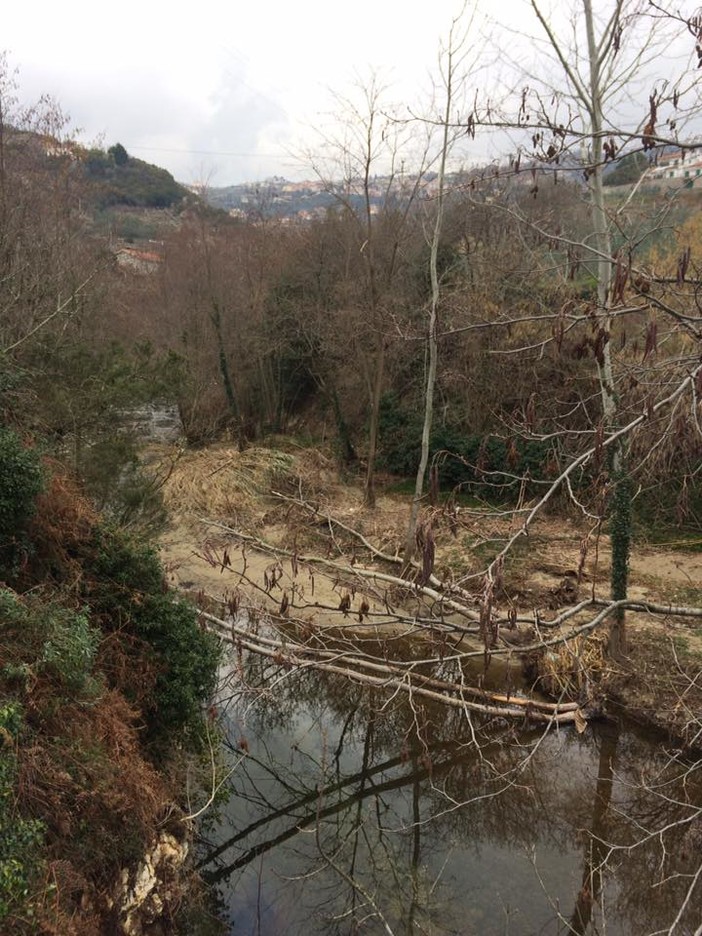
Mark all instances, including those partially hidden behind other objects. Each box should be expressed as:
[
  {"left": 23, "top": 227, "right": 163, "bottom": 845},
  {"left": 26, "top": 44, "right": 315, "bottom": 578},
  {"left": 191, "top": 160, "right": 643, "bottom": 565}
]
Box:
[{"left": 468, "top": 0, "right": 693, "bottom": 656}]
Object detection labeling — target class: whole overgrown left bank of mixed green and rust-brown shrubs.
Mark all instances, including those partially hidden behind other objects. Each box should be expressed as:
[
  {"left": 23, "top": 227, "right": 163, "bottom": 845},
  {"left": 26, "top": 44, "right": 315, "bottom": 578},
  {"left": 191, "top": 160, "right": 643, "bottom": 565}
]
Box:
[{"left": 0, "top": 444, "right": 219, "bottom": 936}]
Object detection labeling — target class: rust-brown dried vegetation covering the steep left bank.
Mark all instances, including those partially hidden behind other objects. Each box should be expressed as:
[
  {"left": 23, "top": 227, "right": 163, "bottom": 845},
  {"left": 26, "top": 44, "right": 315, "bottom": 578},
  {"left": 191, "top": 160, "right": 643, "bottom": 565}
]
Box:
[{"left": 0, "top": 465, "right": 212, "bottom": 936}]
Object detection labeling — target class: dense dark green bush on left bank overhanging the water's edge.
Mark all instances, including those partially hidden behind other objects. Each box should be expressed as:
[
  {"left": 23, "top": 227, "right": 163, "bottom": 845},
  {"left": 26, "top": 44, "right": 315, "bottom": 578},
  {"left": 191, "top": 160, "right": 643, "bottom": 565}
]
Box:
[{"left": 85, "top": 528, "right": 220, "bottom": 747}]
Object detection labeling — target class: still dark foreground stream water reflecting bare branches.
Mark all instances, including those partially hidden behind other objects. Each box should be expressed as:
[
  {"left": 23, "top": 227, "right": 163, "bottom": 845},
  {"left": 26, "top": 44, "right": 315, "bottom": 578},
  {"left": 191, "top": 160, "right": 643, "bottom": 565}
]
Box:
[{"left": 199, "top": 640, "right": 702, "bottom": 936}]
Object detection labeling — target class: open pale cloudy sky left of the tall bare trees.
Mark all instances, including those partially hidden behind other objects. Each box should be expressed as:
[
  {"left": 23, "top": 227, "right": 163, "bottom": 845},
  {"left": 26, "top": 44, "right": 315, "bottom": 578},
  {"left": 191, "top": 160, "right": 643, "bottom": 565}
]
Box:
[{"left": 0, "top": 0, "right": 496, "bottom": 186}]
